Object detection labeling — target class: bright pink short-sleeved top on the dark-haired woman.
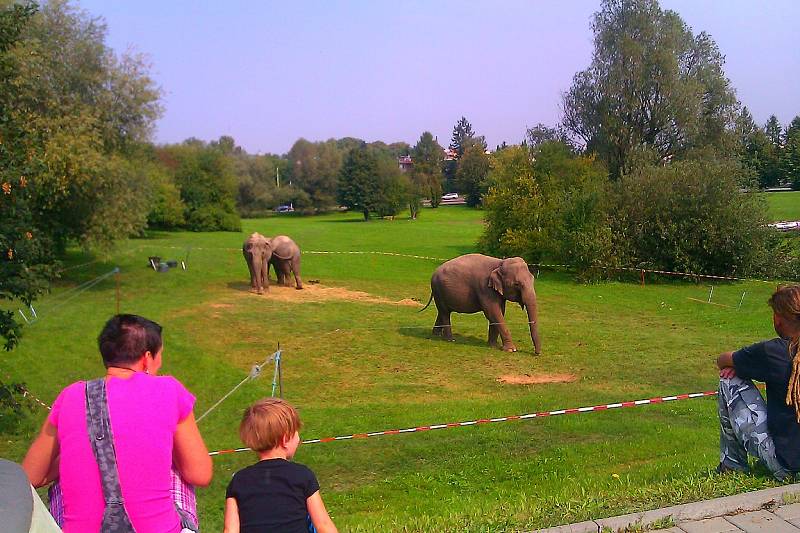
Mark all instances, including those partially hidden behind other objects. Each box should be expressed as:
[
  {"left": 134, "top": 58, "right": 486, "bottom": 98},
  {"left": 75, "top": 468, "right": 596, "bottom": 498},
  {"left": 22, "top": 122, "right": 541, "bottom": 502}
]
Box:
[{"left": 49, "top": 372, "right": 195, "bottom": 533}]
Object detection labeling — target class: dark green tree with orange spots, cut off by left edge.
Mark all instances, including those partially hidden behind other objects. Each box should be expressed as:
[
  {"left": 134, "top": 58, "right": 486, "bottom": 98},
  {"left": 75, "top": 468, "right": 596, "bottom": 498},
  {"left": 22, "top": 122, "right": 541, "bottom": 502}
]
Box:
[{"left": 0, "top": 4, "right": 54, "bottom": 350}]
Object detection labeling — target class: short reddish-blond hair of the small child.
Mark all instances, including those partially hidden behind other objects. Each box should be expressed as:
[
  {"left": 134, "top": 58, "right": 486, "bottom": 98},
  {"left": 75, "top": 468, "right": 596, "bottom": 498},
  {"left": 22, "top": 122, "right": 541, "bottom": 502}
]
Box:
[{"left": 239, "top": 398, "right": 302, "bottom": 452}]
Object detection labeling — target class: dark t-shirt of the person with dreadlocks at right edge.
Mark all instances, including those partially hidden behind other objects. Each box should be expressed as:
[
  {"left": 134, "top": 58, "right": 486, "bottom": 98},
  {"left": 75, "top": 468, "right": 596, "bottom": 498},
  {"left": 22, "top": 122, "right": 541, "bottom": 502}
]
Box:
[{"left": 733, "top": 339, "right": 800, "bottom": 472}]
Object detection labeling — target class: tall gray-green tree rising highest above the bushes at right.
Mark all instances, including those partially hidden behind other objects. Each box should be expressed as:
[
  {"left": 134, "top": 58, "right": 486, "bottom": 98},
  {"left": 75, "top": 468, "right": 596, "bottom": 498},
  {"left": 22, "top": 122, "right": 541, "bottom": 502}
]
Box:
[{"left": 563, "top": 0, "right": 738, "bottom": 179}]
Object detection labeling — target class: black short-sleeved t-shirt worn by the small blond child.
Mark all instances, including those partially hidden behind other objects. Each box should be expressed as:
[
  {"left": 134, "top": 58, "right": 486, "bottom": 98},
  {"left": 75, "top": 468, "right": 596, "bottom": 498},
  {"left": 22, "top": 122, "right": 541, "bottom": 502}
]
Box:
[{"left": 225, "top": 459, "right": 319, "bottom": 533}]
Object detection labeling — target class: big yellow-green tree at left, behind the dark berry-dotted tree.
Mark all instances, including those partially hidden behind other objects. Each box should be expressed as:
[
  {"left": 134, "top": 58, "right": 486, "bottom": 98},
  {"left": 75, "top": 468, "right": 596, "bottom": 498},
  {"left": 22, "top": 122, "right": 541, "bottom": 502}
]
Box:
[{"left": 9, "top": 0, "right": 161, "bottom": 251}]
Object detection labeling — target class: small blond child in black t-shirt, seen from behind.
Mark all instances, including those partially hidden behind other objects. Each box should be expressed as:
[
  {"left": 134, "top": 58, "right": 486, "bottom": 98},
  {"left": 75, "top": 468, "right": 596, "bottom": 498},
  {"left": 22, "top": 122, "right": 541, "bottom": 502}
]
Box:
[{"left": 225, "top": 398, "right": 337, "bottom": 533}]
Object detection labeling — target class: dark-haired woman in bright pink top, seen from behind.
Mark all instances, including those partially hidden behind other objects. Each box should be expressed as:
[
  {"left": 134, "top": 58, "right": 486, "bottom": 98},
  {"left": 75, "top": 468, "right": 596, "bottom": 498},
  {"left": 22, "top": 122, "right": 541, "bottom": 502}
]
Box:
[{"left": 22, "top": 315, "right": 212, "bottom": 533}]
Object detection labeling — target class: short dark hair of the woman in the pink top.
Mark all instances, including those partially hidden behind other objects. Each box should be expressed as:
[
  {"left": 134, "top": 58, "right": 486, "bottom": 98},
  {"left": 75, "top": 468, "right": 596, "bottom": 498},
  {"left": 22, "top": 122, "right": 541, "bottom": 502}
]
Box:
[{"left": 97, "top": 315, "right": 162, "bottom": 367}]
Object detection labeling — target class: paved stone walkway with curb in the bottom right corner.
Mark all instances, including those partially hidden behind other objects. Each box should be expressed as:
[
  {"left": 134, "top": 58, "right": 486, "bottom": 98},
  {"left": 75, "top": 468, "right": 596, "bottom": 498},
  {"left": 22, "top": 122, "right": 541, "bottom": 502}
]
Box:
[{"left": 538, "top": 483, "right": 800, "bottom": 533}]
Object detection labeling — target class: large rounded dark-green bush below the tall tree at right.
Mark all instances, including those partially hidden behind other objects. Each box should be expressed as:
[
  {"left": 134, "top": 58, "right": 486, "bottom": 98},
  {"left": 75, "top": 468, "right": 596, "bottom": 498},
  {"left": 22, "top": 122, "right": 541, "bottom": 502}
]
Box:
[{"left": 610, "top": 155, "right": 774, "bottom": 276}]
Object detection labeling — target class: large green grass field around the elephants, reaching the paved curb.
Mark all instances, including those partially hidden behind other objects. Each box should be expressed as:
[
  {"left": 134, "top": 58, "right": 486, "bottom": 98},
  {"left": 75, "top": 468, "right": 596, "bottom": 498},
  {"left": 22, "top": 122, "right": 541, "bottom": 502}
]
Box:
[{"left": 0, "top": 207, "right": 788, "bottom": 531}]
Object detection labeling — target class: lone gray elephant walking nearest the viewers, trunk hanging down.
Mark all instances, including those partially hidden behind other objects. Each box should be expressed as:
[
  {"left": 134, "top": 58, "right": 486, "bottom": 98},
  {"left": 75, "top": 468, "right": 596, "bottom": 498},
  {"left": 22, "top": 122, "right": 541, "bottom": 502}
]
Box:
[{"left": 420, "top": 254, "right": 542, "bottom": 355}]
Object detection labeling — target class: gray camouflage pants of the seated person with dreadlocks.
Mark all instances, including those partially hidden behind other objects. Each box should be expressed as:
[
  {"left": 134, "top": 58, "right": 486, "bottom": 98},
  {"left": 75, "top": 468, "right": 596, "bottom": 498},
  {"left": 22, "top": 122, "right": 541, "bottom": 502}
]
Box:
[{"left": 717, "top": 377, "right": 791, "bottom": 480}]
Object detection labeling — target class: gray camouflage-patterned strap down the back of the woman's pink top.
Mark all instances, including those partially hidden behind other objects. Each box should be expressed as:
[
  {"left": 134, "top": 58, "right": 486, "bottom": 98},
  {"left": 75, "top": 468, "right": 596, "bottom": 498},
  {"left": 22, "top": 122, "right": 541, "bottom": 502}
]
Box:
[{"left": 86, "top": 378, "right": 135, "bottom": 533}]
